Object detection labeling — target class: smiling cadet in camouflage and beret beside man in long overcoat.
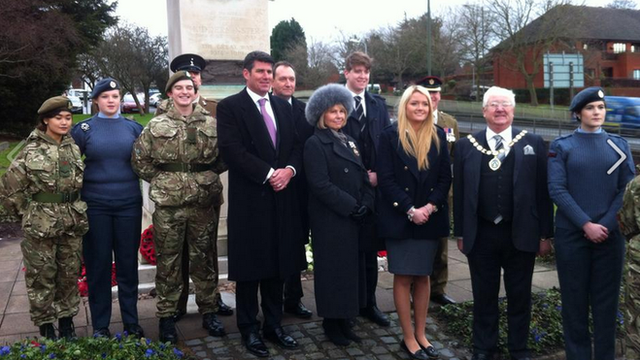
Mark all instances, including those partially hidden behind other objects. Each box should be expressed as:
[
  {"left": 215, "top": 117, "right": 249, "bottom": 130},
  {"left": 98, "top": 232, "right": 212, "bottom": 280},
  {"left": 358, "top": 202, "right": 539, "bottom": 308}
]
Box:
[{"left": 131, "top": 71, "right": 226, "bottom": 343}]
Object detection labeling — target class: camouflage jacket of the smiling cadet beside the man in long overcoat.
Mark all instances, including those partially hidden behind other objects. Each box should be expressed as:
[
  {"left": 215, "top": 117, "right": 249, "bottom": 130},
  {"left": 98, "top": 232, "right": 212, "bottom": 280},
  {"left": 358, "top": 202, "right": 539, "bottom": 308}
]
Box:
[{"left": 131, "top": 105, "right": 227, "bottom": 207}]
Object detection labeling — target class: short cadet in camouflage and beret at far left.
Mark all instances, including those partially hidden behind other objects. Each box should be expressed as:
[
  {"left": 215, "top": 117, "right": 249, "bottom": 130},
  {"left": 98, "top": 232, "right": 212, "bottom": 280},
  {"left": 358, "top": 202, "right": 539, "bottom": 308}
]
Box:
[{"left": 0, "top": 96, "right": 89, "bottom": 339}]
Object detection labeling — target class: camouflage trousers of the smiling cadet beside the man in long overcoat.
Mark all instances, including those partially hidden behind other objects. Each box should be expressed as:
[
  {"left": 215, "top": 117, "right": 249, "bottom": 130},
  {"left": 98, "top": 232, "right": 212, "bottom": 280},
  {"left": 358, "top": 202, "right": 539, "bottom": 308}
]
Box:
[{"left": 153, "top": 206, "right": 218, "bottom": 318}]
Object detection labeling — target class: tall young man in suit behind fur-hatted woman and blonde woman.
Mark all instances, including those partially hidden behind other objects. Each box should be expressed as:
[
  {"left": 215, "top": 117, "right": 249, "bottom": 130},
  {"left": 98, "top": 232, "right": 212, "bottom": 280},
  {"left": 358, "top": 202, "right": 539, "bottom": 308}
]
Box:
[{"left": 342, "top": 51, "right": 391, "bottom": 326}]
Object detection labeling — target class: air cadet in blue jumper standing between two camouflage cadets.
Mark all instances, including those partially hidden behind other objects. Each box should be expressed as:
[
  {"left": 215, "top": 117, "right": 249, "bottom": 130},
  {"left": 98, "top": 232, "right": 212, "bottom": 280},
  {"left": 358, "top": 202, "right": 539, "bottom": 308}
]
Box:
[{"left": 71, "top": 78, "right": 144, "bottom": 337}]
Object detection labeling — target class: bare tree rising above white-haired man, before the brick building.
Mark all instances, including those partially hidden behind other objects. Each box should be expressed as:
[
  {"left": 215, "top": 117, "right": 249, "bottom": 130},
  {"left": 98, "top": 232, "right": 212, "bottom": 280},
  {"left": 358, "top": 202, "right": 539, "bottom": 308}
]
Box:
[{"left": 488, "top": 0, "right": 581, "bottom": 106}]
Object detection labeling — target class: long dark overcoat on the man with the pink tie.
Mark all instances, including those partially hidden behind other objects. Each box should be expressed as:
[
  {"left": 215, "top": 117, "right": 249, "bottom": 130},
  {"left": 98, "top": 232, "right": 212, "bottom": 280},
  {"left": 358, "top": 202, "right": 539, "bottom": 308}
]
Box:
[{"left": 217, "top": 88, "right": 305, "bottom": 281}]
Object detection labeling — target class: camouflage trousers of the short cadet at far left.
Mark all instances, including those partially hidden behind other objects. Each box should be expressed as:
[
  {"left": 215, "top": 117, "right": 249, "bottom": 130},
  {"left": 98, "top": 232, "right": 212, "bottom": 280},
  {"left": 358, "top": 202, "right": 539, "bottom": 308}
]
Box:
[{"left": 20, "top": 236, "right": 82, "bottom": 326}]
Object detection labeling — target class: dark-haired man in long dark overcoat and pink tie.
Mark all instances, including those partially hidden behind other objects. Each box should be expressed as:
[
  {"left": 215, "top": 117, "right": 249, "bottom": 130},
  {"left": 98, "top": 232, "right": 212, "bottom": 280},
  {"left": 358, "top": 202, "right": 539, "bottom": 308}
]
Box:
[{"left": 218, "top": 51, "right": 304, "bottom": 357}]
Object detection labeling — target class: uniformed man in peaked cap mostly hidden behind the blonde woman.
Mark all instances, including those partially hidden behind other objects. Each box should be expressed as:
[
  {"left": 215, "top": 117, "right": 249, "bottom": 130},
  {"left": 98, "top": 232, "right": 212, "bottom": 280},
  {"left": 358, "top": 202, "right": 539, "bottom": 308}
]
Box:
[{"left": 419, "top": 76, "right": 460, "bottom": 305}]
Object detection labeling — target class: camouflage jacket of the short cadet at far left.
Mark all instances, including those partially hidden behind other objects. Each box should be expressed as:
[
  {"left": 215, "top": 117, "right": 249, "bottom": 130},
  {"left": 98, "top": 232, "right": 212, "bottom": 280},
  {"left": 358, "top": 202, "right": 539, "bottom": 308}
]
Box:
[{"left": 0, "top": 130, "right": 89, "bottom": 238}]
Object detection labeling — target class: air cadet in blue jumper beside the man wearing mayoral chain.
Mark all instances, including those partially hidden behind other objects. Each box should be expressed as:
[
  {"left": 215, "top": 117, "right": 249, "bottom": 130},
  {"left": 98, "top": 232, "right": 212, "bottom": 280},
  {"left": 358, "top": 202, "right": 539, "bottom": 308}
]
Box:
[{"left": 548, "top": 87, "right": 634, "bottom": 360}]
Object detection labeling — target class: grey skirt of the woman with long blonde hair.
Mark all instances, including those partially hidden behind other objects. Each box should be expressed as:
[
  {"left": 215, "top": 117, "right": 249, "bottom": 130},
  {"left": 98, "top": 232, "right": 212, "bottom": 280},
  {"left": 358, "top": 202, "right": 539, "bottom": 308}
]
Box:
[{"left": 385, "top": 239, "right": 439, "bottom": 276}]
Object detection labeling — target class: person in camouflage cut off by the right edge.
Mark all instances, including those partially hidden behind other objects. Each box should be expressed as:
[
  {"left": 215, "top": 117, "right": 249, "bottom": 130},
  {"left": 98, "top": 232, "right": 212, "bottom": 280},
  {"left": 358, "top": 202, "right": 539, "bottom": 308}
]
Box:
[{"left": 618, "top": 166, "right": 640, "bottom": 359}]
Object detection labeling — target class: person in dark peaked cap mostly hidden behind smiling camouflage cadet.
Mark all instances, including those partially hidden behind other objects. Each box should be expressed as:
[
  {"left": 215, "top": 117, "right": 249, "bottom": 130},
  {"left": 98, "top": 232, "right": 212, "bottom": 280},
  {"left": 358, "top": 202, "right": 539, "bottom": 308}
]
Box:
[{"left": 155, "top": 54, "right": 233, "bottom": 321}]
